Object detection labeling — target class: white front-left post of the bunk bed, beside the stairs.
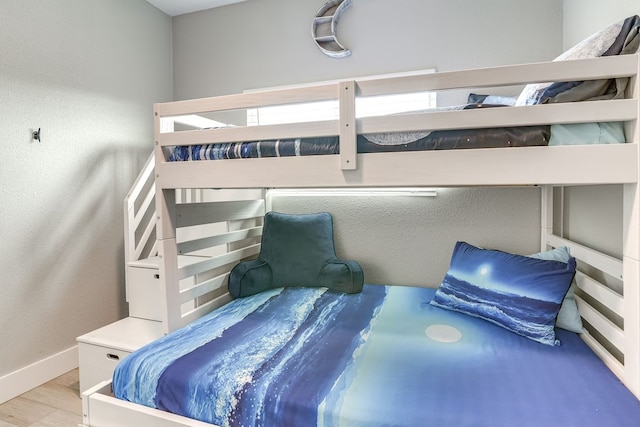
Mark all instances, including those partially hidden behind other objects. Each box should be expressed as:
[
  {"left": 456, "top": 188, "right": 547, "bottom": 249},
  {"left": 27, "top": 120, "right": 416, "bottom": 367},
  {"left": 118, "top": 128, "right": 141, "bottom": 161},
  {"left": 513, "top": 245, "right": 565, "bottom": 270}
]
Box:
[{"left": 154, "top": 104, "right": 180, "bottom": 334}]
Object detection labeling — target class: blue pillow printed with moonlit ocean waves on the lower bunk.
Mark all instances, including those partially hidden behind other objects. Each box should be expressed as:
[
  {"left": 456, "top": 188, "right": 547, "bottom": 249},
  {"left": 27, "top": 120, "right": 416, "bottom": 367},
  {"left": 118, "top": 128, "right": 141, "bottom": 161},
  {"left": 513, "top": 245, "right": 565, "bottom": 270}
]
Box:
[{"left": 431, "top": 242, "right": 576, "bottom": 345}]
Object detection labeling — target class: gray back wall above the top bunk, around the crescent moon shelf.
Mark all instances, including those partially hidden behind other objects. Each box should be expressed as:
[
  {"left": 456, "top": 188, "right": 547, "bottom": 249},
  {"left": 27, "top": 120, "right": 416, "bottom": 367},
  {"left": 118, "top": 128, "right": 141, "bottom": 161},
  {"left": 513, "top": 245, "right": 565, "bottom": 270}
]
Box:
[{"left": 173, "top": 0, "right": 562, "bottom": 99}]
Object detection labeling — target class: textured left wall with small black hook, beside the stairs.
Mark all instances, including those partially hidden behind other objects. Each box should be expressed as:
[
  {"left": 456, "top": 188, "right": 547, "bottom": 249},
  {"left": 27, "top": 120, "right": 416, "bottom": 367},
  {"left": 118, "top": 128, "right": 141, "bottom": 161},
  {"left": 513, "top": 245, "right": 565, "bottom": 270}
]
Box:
[{"left": 0, "top": 0, "right": 172, "bottom": 394}]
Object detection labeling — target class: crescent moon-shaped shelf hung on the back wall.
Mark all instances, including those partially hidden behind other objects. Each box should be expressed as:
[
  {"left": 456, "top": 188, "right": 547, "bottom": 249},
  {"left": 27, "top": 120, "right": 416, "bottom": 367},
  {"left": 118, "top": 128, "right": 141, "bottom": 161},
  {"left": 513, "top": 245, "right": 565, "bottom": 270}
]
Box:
[{"left": 311, "top": 0, "right": 351, "bottom": 58}]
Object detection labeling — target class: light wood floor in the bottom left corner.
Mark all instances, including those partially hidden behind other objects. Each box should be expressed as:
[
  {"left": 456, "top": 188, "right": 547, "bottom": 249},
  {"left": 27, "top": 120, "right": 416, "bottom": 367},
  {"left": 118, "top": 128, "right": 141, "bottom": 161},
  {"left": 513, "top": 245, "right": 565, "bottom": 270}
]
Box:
[{"left": 0, "top": 369, "right": 82, "bottom": 427}]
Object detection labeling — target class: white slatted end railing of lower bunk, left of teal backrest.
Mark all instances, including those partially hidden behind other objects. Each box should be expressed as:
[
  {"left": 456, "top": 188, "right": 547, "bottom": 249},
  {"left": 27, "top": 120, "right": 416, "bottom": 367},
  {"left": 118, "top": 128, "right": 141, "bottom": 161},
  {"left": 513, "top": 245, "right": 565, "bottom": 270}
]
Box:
[{"left": 158, "top": 190, "right": 265, "bottom": 332}]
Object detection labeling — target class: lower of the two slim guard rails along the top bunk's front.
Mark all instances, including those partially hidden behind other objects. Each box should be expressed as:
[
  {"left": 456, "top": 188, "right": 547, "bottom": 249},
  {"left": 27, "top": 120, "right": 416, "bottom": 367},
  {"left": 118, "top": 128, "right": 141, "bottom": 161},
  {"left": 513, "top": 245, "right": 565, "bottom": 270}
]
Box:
[{"left": 159, "top": 99, "right": 638, "bottom": 152}]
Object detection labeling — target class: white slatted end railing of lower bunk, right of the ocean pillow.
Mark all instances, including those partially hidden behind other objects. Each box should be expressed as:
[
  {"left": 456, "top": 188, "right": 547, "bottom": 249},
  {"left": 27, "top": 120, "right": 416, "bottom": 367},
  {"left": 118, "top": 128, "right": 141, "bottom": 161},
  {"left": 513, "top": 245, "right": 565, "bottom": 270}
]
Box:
[{"left": 542, "top": 184, "right": 640, "bottom": 397}]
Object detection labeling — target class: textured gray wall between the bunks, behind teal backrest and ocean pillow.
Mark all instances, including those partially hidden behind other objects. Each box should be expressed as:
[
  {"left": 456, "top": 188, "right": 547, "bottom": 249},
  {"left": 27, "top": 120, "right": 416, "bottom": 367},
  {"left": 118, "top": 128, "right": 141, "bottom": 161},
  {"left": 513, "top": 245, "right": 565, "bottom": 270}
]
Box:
[{"left": 272, "top": 187, "right": 540, "bottom": 287}]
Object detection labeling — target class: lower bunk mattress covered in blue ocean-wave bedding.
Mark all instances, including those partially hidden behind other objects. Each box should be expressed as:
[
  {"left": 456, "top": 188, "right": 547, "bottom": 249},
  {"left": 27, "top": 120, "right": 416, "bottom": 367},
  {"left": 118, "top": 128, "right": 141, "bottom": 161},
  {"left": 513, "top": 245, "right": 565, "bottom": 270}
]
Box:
[{"left": 113, "top": 285, "right": 640, "bottom": 427}]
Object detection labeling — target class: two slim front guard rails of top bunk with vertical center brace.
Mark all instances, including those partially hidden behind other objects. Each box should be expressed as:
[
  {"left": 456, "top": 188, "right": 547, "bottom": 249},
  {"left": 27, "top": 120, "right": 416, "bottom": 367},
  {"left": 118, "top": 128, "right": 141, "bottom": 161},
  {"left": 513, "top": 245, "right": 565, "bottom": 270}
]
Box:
[{"left": 155, "top": 55, "right": 638, "bottom": 175}]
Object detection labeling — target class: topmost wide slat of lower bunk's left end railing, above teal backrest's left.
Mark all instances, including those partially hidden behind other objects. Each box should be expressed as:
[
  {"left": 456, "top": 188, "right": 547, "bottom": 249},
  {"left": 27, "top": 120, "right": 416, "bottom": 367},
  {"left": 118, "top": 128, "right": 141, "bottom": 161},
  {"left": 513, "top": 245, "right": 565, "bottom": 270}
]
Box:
[{"left": 176, "top": 200, "right": 264, "bottom": 228}]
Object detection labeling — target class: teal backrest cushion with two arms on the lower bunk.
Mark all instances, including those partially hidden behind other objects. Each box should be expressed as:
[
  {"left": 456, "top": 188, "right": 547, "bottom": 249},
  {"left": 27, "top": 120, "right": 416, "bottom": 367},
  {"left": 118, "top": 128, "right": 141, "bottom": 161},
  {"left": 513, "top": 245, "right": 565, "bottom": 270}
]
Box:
[{"left": 229, "top": 212, "right": 364, "bottom": 297}]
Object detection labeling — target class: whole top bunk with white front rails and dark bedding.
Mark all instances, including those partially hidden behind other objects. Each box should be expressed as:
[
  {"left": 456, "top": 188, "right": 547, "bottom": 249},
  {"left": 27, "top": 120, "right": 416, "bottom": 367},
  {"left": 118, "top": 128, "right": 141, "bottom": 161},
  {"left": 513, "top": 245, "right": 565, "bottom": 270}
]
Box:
[{"left": 154, "top": 53, "right": 640, "bottom": 189}]
